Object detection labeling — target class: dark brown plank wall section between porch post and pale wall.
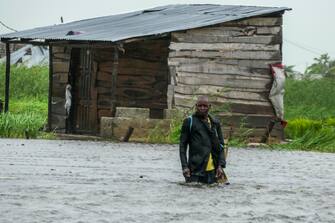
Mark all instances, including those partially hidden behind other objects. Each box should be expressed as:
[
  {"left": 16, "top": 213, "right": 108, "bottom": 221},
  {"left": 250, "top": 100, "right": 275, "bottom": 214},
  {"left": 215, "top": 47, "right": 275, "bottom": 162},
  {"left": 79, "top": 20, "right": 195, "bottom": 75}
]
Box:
[{"left": 117, "top": 38, "right": 169, "bottom": 110}]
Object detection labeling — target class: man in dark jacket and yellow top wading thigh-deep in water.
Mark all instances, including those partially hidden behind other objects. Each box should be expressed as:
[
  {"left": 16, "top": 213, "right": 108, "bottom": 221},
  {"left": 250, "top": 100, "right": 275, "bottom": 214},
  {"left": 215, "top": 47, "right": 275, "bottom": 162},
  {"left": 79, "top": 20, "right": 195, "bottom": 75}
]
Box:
[{"left": 179, "top": 96, "right": 226, "bottom": 184}]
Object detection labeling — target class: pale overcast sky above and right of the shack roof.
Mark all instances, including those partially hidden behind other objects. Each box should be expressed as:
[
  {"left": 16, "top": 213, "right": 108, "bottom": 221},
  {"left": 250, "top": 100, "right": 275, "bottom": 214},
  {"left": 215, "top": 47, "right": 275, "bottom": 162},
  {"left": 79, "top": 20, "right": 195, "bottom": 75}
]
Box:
[{"left": 0, "top": 0, "right": 335, "bottom": 71}]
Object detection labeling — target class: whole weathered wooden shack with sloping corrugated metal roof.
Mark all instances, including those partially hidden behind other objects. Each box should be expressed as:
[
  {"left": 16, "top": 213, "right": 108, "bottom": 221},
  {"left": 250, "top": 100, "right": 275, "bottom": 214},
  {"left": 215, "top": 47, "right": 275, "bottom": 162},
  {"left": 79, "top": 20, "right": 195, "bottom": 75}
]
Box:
[{"left": 1, "top": 5, "right": 288, "bottom": 139}]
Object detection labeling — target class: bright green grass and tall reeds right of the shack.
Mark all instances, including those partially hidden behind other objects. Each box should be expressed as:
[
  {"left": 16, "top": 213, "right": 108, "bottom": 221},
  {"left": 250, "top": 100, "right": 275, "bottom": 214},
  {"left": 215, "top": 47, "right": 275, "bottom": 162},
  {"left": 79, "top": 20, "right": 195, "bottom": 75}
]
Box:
[{"left": 280, "top": 78, "right": 335, "bottom": 152}]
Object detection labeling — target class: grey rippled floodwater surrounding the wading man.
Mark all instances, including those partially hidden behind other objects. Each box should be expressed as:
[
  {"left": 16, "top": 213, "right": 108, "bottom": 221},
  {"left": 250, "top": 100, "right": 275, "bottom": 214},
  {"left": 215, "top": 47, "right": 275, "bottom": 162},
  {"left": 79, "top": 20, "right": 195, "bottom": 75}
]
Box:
[{"left": 0, "top": 139, "right": 335, "bottom": 223}]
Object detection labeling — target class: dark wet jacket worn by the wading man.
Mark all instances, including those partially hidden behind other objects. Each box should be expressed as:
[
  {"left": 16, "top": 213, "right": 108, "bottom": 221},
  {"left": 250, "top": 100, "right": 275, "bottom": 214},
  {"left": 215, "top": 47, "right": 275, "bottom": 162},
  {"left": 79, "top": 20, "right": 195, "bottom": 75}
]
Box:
[{"left": 179, "top": 114, "right": 226, "bottom": 176}]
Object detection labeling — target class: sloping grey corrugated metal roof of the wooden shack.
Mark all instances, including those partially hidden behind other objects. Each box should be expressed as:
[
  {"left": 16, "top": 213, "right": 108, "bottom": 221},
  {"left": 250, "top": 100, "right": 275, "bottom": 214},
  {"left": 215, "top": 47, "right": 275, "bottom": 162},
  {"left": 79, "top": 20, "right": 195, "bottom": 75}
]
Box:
[{"left": 1, "top": 4, "right": 290, "bottom": 42}]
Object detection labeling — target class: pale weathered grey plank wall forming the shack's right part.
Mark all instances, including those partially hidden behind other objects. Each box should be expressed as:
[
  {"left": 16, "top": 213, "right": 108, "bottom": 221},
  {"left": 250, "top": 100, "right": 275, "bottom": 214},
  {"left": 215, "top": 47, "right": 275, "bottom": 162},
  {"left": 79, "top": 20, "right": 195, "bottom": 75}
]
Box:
[{"left": 168, "top": 15, "right": 282, "bottom": 138}]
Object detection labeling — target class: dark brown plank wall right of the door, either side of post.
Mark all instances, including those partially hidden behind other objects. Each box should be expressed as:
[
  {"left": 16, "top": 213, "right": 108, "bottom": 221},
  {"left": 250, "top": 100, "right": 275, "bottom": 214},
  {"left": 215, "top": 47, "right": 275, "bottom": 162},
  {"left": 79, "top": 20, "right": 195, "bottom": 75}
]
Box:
[{"left": 94, "top": 39, "right": 169, "bottom": 122}]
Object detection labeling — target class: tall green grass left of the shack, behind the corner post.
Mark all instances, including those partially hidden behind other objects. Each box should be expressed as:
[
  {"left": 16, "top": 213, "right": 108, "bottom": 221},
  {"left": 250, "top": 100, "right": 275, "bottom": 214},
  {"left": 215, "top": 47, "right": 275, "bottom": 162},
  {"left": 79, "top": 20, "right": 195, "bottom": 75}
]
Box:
[{"left": 0, "top": 65, "right": 52, "bottom": 138}]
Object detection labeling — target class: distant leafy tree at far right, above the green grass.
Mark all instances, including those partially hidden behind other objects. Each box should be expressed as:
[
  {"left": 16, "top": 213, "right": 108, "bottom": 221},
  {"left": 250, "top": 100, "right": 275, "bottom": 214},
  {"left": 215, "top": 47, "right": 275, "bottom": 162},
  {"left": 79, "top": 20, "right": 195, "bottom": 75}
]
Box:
[{"left": 305, "top": 53, "right": 335, "bottom": 78}]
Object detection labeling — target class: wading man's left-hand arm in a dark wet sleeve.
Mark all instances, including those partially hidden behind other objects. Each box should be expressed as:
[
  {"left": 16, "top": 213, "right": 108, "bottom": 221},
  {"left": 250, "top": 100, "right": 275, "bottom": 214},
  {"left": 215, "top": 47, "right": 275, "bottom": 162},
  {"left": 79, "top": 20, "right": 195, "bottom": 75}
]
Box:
[{"left": 179, "top": 118, "right": 190, "bottom": 170}]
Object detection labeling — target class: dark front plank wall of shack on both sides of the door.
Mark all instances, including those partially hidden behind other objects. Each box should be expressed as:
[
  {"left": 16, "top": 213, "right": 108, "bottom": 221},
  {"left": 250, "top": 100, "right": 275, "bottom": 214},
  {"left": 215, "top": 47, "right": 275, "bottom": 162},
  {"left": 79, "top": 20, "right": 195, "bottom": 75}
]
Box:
[{"left": 51, "top": 38, "right": 169, "bottom": 132}]
